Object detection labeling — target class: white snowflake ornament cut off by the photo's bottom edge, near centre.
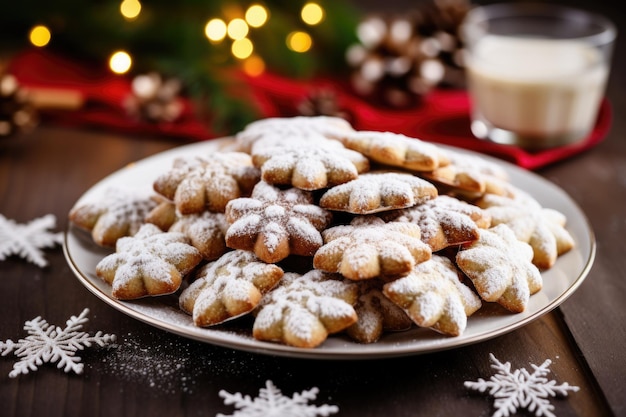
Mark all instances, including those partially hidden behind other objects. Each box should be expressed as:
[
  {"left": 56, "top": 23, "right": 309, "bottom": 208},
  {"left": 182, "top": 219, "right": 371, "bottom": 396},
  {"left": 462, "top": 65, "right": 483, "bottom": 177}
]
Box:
[{"left": 216, "top": 380, "right": 339, "bottom": 417}]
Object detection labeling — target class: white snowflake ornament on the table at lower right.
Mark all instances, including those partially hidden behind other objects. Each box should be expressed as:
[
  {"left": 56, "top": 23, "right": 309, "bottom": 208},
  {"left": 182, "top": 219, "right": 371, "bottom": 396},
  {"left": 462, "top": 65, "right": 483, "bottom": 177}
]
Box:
[{"left": 465, "top": 353, "right": 579, "bottom": 417}]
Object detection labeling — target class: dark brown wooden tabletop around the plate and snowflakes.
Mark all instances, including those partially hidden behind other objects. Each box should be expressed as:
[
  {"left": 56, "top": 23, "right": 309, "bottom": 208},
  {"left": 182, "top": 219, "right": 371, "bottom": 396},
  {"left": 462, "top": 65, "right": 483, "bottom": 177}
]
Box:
[{"left": 0, "top": 1, "right": 626, "bottom": 417}]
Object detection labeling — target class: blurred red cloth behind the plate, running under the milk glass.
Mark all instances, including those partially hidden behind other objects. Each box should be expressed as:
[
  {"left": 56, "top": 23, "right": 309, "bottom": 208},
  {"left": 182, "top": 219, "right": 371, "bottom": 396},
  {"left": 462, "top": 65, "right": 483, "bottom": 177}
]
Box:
[{"left": 9, "top": 50, "right": 612, "bottom": 169}]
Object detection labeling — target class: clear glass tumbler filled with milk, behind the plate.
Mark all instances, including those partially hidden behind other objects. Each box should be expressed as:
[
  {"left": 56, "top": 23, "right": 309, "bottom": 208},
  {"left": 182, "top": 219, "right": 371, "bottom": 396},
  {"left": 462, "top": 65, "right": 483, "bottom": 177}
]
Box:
[{"left": 461, "top": 2, "right": 616, "bottom": 150}]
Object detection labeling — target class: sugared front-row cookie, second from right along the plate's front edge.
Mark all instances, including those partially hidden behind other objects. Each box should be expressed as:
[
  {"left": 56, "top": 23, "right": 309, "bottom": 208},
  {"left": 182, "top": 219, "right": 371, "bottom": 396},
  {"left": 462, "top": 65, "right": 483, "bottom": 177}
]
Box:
[{"left": 383, "top": 255, "right": 481, "bottom": 336}]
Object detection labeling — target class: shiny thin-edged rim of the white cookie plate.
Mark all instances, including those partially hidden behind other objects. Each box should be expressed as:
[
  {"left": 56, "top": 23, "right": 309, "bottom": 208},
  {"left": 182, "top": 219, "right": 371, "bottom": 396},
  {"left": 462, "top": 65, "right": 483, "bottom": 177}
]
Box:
[{"left": 62, "top": 137, "right": 597, "bottom": 360}]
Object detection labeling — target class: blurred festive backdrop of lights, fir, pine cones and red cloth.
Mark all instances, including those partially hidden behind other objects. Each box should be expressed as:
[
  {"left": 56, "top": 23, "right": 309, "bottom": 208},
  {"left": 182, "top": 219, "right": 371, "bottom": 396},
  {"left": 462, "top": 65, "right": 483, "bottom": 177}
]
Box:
[{"left": 0, "top": 0, "right": 626, "bottom": 139}]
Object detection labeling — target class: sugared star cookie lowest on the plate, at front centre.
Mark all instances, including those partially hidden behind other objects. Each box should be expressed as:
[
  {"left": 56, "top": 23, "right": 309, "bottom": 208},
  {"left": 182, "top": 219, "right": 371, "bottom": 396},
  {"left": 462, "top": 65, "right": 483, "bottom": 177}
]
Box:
[{"left": 252, "top": 270, "right": 358, "bottom": 348}]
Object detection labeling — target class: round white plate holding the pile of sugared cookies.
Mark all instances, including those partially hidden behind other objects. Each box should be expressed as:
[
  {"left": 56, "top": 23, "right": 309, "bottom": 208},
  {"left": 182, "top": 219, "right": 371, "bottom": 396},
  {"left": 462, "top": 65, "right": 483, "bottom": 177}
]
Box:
[{"left": 64, "top": 139, "right": 596, "bottom": 359}]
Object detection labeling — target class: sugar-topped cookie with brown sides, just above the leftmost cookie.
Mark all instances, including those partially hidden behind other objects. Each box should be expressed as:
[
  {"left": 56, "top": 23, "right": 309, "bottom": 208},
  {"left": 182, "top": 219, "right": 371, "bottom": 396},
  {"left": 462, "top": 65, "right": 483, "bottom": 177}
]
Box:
[{"left": 153, "top": 152, "right": 260, "bottom": 214}]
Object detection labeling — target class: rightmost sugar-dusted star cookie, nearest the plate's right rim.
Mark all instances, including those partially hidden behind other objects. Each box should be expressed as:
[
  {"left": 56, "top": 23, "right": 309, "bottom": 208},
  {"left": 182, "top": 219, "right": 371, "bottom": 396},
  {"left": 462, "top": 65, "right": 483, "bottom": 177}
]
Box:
[{"left": 476, "top": 185, "right": 575, "bottom": 269}]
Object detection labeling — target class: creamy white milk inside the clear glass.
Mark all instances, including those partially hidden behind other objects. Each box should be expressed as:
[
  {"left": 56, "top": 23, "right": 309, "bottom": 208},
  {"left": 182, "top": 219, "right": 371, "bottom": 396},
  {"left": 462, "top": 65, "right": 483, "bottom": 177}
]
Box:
[{"left": 467, "top": 35, "right": 609, "bottom": 147}]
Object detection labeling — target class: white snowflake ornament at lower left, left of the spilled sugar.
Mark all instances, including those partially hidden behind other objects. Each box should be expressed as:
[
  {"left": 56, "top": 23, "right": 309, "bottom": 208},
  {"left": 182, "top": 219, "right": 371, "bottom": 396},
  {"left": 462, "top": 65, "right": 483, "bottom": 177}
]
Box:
[{"left": 0, "top": 308, "right": 116, "bottom": 378}]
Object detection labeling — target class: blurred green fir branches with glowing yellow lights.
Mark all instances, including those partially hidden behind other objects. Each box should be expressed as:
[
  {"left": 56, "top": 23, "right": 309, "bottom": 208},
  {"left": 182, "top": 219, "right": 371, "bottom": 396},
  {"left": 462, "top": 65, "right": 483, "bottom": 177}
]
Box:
[{"left": 0, "top": 0, "right": 359, "bottom": 133}]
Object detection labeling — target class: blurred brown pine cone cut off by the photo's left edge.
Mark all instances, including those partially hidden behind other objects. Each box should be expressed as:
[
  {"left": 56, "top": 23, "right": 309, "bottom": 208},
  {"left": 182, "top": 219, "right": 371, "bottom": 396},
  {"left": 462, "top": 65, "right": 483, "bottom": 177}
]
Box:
[{"left": 0, "top": 71, "right": 38, "bottom": 138}]
